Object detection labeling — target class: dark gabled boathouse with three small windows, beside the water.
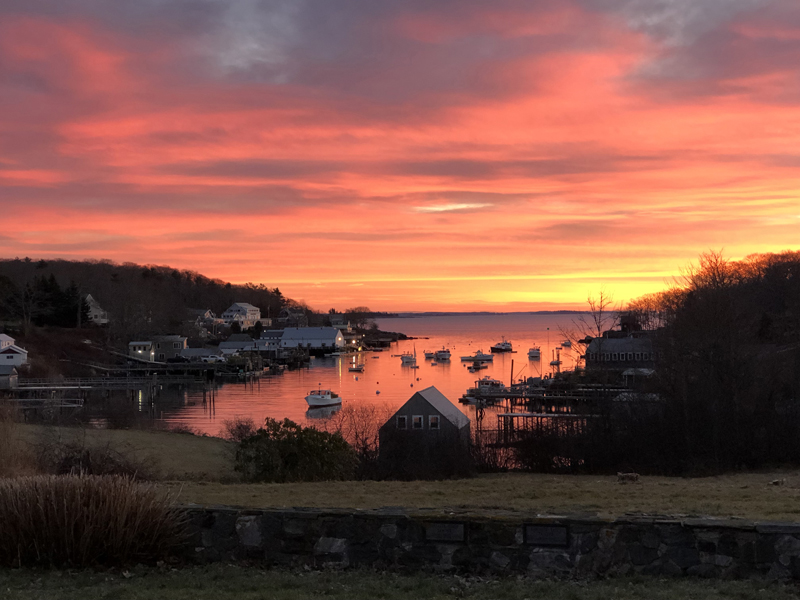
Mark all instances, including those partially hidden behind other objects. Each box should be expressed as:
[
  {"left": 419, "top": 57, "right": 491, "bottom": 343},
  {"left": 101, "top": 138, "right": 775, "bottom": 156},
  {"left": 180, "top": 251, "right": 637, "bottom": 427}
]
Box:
[{"left": 378, "top": 387, "right": 471, "bottom": 479}]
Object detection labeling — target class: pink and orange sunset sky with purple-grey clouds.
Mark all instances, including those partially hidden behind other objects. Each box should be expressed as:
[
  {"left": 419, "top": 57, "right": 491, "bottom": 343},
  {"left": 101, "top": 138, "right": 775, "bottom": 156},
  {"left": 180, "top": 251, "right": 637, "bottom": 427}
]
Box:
[{"left": 0, "top": 0, "right": 800, "bottom": 311}]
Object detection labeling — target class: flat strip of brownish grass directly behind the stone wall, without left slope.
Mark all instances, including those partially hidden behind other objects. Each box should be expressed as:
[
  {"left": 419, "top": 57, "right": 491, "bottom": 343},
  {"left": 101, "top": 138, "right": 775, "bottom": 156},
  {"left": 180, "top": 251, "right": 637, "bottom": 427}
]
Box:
[{"left": 167, "top": 472, "right": 800, "bottom": 521}]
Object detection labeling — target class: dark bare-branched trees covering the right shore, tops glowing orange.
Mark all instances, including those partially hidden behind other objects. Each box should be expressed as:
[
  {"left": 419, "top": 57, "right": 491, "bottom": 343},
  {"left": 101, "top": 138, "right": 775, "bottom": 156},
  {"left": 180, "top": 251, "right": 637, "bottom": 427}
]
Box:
[{"left": 598, "top": 252, "right": 800, "bottom": 473}]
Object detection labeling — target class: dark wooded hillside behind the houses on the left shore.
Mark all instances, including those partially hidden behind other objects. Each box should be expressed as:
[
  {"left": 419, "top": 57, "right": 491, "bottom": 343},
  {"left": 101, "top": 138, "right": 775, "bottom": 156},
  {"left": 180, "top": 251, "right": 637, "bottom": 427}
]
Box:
[{"left": 0, "top": 258, "right": 290, "bottom": 341}]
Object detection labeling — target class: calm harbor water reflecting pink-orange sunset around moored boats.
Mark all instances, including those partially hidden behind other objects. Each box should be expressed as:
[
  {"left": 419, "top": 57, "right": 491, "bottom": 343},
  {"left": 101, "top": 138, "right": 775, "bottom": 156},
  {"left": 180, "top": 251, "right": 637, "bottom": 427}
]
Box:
[{"left": 155, "top": 314, "right": 578, "bottom": 434}]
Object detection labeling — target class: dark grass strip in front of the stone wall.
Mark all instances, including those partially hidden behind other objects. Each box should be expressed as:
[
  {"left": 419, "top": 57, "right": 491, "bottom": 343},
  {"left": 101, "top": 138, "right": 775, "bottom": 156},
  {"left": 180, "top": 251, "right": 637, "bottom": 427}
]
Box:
[{"left": 0, "top": 566, "right": 798, "bottom": 600}]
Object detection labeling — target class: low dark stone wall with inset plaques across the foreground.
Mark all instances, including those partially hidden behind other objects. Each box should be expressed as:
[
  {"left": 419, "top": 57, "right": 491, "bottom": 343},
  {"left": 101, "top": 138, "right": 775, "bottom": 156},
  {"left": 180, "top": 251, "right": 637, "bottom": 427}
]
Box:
[{"left": 186, "top": 507, "right": 800, "bottom": 579}]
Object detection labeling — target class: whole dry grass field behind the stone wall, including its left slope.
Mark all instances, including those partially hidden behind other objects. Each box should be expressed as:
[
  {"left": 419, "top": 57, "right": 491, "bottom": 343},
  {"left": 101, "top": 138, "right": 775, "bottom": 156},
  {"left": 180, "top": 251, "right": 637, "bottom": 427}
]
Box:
[{"left": 0, "top": 423, "right": 800, "bottom": 521}]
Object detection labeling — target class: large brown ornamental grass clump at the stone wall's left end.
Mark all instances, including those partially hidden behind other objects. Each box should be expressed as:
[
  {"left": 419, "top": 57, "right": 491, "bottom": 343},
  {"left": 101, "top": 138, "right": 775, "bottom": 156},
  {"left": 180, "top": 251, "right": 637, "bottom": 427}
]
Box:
[{"left": 0, "top": 475, "right": 187, "bottom": 567}]
